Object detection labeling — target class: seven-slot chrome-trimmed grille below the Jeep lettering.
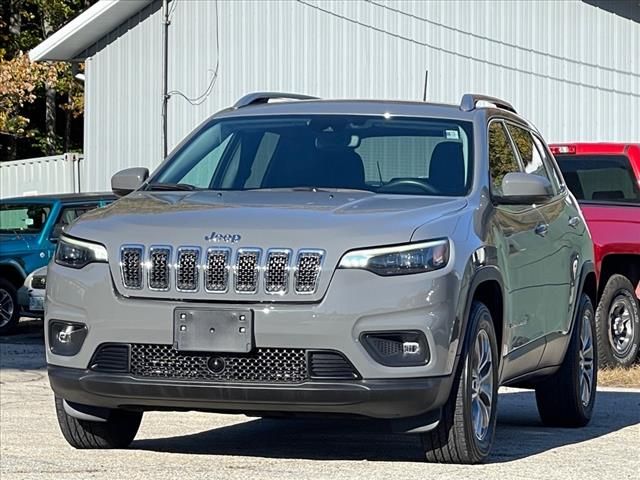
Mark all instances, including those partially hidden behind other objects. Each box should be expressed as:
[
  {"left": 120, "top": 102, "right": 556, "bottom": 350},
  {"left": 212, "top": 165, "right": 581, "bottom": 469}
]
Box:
[{"left": 120, "top": 245, "right": 324, "bottom": 296}]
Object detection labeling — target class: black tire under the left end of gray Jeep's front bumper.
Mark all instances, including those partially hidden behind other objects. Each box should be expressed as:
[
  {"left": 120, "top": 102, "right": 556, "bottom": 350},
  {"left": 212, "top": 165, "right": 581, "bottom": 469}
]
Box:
[{"left": 55, "top": 397, "right": 142, "bottom": 449}]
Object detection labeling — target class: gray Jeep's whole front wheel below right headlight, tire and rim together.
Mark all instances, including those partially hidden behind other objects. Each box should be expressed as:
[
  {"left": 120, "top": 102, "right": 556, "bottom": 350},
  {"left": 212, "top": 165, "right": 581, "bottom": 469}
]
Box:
[{"left": 422, "top": 302, "right": 499, "bottom": 464}]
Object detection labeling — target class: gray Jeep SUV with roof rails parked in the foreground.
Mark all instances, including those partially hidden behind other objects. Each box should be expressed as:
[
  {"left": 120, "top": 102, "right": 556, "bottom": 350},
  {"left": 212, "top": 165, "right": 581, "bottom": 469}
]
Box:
[{"left": 46, "top": 93, "right": 596, "bottom": 463}]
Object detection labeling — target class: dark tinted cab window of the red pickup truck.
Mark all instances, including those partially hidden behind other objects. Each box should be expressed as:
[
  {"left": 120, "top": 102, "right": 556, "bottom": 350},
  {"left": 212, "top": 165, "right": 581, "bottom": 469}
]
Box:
[{"left": 555, "top": 154, "right": 640, "bottom": 203}]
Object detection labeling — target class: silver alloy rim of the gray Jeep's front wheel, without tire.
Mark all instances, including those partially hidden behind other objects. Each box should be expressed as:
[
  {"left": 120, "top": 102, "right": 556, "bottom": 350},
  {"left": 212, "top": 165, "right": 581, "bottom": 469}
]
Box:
[{"left": 471, "top": 330, "right": 494, "bottom": 440}]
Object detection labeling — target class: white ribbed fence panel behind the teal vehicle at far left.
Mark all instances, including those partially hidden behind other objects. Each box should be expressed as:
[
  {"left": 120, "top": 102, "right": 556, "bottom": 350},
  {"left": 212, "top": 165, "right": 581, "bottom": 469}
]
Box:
[{"left": 0, "top": 153, "right": 84, "bottom": 198}]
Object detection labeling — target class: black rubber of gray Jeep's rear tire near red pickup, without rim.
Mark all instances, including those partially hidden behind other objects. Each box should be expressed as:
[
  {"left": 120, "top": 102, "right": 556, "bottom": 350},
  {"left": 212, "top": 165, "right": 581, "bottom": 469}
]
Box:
[{"left": 536, "top": 294, "right": 598, "bottom": 427}]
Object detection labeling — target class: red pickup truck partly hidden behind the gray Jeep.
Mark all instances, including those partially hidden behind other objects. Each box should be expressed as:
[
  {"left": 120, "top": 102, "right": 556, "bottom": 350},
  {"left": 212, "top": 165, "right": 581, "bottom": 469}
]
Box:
[{"left": 550, "top": 143, "right": 640, "bottom": 367}]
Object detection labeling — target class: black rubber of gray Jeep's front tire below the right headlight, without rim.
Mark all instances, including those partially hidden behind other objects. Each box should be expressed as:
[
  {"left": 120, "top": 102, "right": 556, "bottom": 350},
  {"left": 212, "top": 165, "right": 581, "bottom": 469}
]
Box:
[{"left": 421, "top": 302, "right": 499, "bottom": 464}]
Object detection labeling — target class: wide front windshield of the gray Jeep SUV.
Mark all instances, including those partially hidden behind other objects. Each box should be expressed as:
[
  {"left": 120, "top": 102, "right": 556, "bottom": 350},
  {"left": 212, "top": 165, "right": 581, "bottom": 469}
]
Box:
[{"left": 147, "top": 115, "right": 472, "bottom": 196}]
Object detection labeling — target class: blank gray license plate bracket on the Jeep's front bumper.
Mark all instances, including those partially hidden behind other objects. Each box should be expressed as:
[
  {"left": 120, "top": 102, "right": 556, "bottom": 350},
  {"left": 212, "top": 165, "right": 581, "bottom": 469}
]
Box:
[{"left": 173, "top": 308, "right": 254, "bottom": 353}]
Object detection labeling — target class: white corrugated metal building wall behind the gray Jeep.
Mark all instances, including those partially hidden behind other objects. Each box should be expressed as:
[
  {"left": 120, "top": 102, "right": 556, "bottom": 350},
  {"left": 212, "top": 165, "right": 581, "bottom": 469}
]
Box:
[{"left": 85, "top": 0, "right": 640, "bottom": 189}]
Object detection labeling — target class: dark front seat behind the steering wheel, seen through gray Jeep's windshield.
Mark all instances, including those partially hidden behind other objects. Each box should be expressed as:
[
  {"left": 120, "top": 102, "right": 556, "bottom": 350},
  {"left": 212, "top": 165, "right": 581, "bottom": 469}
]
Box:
[{"left": 429, "top": 142, "right": 466, "bottom": 195}]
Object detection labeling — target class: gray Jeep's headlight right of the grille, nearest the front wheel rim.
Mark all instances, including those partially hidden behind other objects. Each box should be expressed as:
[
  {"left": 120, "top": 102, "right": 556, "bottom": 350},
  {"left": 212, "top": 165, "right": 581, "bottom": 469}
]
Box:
[{"left": 338, "top": 239, "right": 449, "bottom": 276}]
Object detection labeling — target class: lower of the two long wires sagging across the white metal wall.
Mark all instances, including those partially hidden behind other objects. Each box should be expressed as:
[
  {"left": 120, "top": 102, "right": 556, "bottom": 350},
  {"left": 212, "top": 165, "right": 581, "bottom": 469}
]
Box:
[{"left": 296, "top": 0, "right": 640, "bottom": 98}]
